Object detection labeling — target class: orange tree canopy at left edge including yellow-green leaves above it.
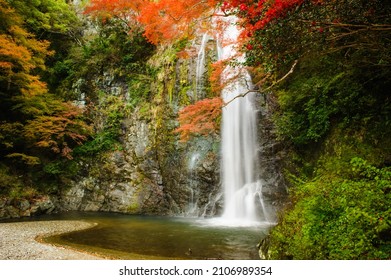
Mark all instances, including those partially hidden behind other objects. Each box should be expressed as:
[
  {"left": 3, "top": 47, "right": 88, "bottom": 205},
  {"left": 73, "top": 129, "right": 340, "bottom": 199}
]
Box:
[{"left": 0, "top": 0, "right": 91, "bottom": 197}]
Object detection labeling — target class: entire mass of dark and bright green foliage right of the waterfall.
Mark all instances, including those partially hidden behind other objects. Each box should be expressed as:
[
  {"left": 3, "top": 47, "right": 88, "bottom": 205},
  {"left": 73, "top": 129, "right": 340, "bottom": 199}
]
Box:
[{"left": 260, "top": 0, "right": 391, "bottom": 259}]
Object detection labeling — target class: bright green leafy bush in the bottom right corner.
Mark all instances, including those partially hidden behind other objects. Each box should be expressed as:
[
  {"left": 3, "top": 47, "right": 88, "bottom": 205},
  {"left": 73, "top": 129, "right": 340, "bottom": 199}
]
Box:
[{"left": 271, "top": 154, "right": 391, "bottom": 259}]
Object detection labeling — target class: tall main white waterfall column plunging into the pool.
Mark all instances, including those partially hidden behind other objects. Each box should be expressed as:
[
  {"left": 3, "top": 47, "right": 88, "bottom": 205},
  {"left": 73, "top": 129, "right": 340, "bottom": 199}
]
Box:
[{"left": 218, "top": 17, "right": 268, "bottom": 222}]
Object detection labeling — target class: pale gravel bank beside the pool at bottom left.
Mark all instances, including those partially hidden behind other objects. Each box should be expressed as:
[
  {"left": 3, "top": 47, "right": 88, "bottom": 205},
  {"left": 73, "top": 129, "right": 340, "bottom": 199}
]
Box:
[{"left": 0, "top": 221, "right": 101, "bottom": 260}]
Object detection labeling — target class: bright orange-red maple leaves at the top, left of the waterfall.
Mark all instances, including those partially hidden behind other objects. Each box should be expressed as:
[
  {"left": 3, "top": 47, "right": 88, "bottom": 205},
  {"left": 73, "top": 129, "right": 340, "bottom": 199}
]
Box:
[{"left": 85, "top": 0, "right": 219, "bottom": 44}]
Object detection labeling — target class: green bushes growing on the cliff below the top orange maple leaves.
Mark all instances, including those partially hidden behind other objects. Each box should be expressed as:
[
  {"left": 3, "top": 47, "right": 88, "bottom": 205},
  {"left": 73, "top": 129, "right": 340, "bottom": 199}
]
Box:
[{"left": 48, "top": 14, "right": 154, "bottom": 160}]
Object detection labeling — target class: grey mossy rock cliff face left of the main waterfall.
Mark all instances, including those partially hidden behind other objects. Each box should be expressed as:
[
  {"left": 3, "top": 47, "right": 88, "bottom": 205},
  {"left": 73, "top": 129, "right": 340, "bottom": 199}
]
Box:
[{"left": 58, "top": 38, "right": 224, "bottom": 216}]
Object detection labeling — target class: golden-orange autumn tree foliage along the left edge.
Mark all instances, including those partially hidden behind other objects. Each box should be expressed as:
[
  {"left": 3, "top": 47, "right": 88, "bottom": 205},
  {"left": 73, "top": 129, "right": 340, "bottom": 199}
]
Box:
[{"left": 0, "top": 0, "right": 90, "bottom": 164}]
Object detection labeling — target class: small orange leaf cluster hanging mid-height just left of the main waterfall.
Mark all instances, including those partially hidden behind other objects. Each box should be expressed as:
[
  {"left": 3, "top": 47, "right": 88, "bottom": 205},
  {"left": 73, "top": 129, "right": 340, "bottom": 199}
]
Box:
[{"left": 175, "top": 97, "right": 223, "bottom": 142}]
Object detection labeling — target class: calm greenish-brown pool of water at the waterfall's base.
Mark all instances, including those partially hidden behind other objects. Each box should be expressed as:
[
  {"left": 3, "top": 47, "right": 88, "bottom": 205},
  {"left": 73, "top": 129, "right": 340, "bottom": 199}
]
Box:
[{"left": 40, "top": 213, "right": 269, "bottom": 260}]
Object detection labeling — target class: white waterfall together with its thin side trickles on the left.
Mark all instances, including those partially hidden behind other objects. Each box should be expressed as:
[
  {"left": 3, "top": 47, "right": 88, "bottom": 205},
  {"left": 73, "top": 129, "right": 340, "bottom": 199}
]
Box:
[{"left": 185, "top": 17, "right": 272, "bottom": 226}]
